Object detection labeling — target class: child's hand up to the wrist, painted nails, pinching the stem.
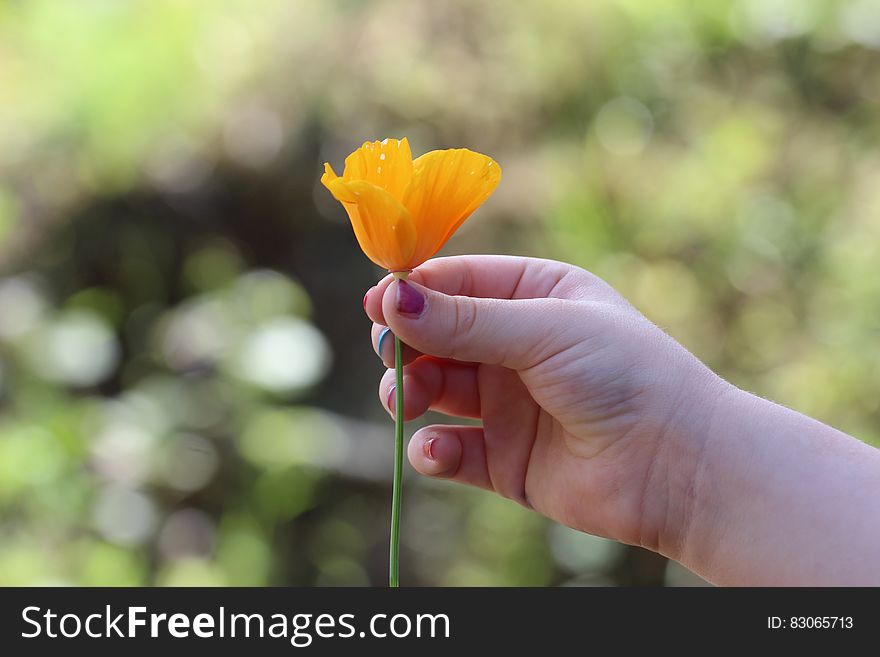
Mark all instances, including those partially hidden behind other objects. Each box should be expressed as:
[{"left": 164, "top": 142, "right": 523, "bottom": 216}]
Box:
[{"left": 365, "top": 256, "right": 729, "bottom": 556}]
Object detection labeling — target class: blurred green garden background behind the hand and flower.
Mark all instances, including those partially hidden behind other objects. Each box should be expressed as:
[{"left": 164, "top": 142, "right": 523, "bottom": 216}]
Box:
[{"left": 0, "top": 0, "right": 880, "bottom": 586}]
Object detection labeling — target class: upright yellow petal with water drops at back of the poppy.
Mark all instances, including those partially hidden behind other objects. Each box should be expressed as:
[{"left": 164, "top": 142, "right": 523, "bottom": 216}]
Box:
[{"left": 342, "top": 137, "right": 413, "bottom": 201}]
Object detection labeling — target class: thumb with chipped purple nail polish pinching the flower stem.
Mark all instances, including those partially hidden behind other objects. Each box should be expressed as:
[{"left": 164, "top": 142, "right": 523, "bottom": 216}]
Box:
[{"left": 382, "top": 280, "right": 576, "bottom": 370}]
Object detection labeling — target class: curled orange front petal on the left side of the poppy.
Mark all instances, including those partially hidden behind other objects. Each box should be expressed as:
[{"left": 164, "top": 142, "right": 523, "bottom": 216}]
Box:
[{"left": 321, "top": 176, "right": 416, "bottom": 271}]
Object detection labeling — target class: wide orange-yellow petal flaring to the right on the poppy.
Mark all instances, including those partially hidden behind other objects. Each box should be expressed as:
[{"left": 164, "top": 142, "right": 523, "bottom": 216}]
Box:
[{"left": 403, "top": 148, "right": 501, "bottom": 264}]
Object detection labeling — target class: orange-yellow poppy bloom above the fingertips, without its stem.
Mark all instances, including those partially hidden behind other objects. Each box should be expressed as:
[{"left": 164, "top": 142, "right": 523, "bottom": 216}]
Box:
[{"left": 321, "top": 138, "right": 501, "bottom": 271}]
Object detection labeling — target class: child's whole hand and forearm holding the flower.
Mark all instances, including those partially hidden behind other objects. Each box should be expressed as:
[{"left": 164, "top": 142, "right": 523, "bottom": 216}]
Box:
[{"left": 364, "top": 256, "right": 880, "bottom": 585}]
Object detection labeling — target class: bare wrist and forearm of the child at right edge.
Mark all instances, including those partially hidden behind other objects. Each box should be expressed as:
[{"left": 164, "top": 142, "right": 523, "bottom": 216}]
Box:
[{"left": 670, "top": 386, "right": 880, "bottom": 586}]
